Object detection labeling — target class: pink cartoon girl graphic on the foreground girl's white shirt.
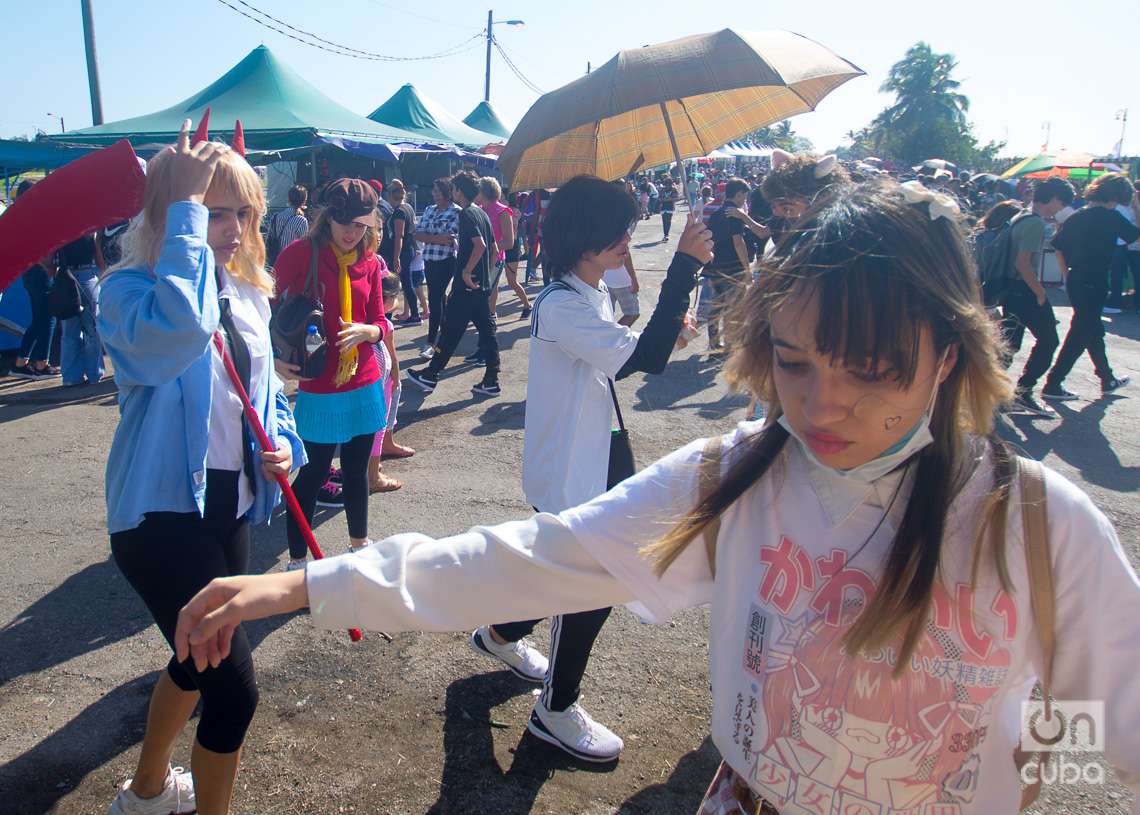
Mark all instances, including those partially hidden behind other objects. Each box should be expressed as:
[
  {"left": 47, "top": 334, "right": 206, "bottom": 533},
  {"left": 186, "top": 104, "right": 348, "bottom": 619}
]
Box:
[{"left": 754, "top": 604, "right": 1009, "bottom": 814}]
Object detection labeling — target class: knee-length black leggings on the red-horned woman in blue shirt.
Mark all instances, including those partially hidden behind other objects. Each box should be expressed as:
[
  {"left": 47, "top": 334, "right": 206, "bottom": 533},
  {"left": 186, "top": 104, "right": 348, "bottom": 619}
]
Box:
[{"left": 111, "top": 470, "right": 258, "bottom": 752}]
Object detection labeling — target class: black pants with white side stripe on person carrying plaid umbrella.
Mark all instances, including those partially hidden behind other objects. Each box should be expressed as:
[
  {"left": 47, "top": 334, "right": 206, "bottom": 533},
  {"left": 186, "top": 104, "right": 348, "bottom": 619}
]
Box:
[{"left": 492, "top": 609, "right": 612, "bottom": 711}]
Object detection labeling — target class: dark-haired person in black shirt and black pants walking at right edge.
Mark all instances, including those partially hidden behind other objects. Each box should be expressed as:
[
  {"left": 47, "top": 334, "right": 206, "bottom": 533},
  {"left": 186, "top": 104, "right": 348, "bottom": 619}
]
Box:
[{"left": 1041, "top": 173, "right": 1140, "bottom": 401}]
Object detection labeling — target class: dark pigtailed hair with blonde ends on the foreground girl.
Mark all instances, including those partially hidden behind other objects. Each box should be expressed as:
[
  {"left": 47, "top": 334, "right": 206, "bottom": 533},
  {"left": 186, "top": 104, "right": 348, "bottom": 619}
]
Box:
[{"left": 643, "top": 181, "right": 1015, "bottom": 675}]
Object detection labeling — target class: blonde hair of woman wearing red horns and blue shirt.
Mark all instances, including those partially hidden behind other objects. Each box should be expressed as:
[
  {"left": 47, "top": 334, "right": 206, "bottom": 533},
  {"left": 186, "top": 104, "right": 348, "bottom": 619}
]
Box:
[{"left": 107, "top": 144, "right": 274, "bottom": 296}]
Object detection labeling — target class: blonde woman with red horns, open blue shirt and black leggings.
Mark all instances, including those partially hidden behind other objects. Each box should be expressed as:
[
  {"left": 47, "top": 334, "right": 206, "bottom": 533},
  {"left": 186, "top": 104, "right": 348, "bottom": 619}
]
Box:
[{"left": 98, "top": 122, "right": 304, "bottom": 815}]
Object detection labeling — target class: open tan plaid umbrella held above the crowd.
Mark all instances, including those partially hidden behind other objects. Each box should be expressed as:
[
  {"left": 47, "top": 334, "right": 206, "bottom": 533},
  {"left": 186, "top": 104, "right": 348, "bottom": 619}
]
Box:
[{"left": 498, "top": 28, "right": 863, "bottom": 196}]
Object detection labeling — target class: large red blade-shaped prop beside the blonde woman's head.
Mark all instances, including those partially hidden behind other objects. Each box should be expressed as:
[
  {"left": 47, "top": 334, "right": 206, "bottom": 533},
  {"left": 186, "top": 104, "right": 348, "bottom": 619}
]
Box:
[{"left": 0, "top": 139, "right": 146, "bottom": 291}]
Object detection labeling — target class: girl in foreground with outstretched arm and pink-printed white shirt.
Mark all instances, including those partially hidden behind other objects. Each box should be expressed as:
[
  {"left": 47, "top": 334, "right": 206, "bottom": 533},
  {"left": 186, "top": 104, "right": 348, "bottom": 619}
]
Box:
[{"left": 176, "top": 182, "right": 1140, "bottom": 815}]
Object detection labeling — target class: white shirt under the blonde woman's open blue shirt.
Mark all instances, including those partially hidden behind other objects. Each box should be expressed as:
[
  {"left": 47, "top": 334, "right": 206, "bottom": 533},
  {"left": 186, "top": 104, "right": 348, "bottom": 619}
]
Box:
[{"left": 206, "top": 269, "right": 272, "bottom": 517}]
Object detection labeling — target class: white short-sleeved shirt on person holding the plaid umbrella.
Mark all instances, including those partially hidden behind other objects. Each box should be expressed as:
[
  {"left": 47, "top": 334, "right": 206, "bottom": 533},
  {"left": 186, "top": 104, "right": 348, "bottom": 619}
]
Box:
[{"left": 522, "top": 274, "right": 641, "bottom": 512}]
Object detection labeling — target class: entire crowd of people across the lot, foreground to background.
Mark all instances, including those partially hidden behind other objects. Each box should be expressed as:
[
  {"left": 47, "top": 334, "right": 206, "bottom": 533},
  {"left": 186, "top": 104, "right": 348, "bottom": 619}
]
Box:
[{"left": 2, "top": 122, "right": 1140, "bottom": 815}]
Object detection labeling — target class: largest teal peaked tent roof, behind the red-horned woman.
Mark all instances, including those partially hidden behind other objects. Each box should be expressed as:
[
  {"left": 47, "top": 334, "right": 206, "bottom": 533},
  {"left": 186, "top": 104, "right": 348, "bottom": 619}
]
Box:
[{"left": 51, "top": 46, "right": 428, "bottom": 149}]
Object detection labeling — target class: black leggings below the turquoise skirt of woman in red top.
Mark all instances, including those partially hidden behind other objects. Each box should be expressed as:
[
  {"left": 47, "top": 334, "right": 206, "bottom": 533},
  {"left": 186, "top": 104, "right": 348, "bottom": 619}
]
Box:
[{"left": 285, "top": 433, "right": 376, "bottom": 560}]
